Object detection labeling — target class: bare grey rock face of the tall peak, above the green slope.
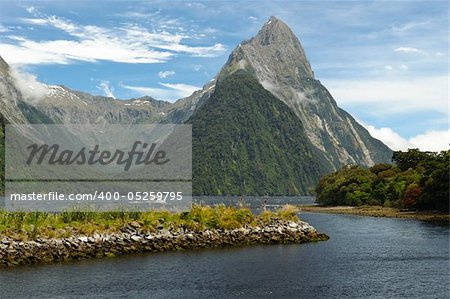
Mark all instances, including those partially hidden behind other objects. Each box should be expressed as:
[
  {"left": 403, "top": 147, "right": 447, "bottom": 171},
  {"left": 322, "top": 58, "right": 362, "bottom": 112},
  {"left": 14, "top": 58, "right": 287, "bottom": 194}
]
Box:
[{"left": 218, "top": 17, "right": 391, "bottom": 168}]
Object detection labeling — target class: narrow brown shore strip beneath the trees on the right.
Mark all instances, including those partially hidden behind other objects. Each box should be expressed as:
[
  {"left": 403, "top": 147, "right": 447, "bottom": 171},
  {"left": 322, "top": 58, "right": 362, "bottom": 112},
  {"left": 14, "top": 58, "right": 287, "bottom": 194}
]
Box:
[{"left": 299, "top": 205, "right": 450, "bottom": 223}]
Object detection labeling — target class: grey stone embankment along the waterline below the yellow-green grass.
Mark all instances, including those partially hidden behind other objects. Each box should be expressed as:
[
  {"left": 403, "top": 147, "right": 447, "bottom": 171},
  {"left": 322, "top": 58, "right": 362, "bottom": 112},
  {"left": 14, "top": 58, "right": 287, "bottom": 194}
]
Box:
[{"left": 0, "top": 219, "right": 328, "bottom": 268}]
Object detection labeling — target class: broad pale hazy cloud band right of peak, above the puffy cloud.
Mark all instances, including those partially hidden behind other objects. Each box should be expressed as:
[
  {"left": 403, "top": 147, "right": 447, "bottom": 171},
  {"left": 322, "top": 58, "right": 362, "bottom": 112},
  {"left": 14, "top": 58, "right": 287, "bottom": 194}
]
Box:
[{"left": 323, "top": 76, "right": 449, "bottom": 115}]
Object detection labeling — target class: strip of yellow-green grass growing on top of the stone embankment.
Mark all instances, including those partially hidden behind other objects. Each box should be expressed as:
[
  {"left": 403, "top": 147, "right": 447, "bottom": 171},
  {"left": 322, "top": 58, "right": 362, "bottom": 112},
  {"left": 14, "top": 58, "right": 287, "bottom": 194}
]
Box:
[{"left": 0, "top": 205, "right": 299, "bottom": 240}]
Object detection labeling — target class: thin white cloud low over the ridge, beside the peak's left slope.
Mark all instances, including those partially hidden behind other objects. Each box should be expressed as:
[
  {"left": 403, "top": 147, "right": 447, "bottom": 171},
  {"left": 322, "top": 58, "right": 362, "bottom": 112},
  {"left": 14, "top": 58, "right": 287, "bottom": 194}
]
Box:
[{"left": 120, "top": 83, "right": 200, "bottom": 102}]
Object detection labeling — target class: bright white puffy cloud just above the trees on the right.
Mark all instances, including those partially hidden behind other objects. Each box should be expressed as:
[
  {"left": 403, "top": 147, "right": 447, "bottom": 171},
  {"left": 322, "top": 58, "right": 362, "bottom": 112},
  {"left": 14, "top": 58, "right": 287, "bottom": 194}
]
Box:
[{"left": 361, "top": 122, "right": 450, "bottom": 152}]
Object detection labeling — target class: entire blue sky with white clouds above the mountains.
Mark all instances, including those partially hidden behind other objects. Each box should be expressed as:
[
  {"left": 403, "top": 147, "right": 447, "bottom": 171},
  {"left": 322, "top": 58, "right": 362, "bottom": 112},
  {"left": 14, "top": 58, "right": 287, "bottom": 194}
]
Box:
[{"left": 0, "top": 1, "right": 450, "bottom": 150}]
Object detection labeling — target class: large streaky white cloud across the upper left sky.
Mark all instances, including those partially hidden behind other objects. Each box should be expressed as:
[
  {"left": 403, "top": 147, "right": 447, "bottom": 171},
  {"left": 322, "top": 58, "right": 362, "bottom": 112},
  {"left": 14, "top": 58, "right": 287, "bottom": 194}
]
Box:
[{"left": 0, "top": 8, "right": 226, "bottom": 64}]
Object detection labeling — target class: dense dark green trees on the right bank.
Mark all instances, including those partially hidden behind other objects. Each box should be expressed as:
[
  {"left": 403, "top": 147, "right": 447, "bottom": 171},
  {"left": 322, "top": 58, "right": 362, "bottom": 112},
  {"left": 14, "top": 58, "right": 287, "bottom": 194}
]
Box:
[{"left": 316, "top": 149, "right": 450, "bottom": 211}]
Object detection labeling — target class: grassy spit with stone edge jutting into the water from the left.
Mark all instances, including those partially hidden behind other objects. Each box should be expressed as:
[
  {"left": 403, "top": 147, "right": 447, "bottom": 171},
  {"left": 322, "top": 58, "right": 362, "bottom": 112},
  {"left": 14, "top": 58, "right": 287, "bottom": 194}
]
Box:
[{"left": 0, "top": 206, "right": 328, "bottom": 268}]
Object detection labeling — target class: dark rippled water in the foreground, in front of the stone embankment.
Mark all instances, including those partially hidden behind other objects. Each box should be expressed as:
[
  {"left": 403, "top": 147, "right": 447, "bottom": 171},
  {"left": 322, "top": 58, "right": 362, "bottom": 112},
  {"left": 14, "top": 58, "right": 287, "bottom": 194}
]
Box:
[{"left": 0, "top": 200, "right": 450, "bottom": 298}]
